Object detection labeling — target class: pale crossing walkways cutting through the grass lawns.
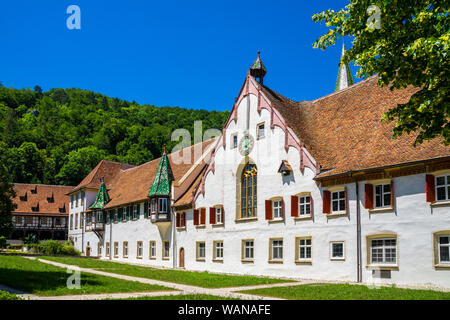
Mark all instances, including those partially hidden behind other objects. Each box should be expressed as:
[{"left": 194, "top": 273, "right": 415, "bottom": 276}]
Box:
[{"left": 4, "top": 257, "right": 311, "bottom": 300}]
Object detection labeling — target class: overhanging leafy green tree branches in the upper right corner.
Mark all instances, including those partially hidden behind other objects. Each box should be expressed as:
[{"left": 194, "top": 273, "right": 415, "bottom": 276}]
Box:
[{"left": 313, "top": 0, "right": 450, "bottom": 145}]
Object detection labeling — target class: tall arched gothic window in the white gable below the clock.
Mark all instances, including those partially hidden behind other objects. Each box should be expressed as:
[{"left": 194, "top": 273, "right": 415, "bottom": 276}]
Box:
[{"left": 241, "top": 164, "right": 258, "bottom": 218}]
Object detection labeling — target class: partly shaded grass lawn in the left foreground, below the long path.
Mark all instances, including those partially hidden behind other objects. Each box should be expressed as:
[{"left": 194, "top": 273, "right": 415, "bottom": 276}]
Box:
[{"left": 0, "top": 256, "right": 172, "bottom": 296}]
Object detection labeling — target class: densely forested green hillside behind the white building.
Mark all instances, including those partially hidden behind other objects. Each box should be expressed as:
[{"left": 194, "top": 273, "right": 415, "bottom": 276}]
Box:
[{"left": 0, "top": 85, "right": 229, "bottom": 185}]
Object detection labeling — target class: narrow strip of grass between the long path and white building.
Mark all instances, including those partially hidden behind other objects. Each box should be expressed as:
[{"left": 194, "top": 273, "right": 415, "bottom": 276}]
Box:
[{"left": 42, "top": 257, "right": 290, "bottom": 288}]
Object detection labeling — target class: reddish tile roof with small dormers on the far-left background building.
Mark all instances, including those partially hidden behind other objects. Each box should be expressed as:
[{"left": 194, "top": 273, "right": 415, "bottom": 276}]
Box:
[{"left": 13, "top": 183, "right": 73, "bottom": 215}]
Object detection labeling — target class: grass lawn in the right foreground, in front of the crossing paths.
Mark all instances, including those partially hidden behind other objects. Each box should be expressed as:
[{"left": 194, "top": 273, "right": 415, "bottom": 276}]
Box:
[{"left": 241, "top": 283, "right": 450, "bottom": 300}]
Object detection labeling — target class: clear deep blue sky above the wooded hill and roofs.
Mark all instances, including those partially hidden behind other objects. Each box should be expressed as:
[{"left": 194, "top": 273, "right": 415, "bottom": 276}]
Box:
[{"left": 0, "top": 0, "right": 356, "bottom": 110}]
